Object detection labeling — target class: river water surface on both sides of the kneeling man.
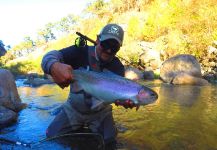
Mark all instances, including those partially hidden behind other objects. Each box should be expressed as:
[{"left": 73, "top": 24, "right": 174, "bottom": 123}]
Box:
[{"left": 0, "top": 81, "right": 217, "bottom": 150}]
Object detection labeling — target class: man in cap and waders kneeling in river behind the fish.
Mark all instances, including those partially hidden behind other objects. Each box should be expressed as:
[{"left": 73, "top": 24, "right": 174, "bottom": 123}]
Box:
[{"left": 42, "top": 24, "right": 124, "bottom": 149}]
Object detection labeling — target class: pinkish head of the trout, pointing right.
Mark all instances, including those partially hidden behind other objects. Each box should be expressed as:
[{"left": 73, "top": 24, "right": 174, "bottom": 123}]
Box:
[{"left": 136, "top": 86, "right": 158, "bottom": 105}]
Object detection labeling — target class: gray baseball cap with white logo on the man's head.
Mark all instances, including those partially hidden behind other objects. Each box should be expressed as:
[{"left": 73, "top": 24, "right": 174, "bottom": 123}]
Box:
[{"left": 99, "top": 24, "right": 124, "bottom": 46}]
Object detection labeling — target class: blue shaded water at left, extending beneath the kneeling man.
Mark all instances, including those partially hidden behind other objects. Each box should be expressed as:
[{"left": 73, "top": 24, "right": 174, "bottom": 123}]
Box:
[{"left": 0, "top": 81, "right": 107, "bottom": 150}]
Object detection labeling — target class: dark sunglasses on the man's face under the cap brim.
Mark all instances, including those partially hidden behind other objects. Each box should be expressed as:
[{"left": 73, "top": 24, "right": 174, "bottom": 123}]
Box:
[{"left": 100, "top": 40, "right": 120, "bottom": 55}]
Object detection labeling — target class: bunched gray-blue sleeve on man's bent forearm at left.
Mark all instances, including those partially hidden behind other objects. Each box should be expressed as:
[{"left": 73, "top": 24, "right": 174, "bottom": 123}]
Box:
[{"left": 41, "top": 50, "right": 63, "bottom": 74}]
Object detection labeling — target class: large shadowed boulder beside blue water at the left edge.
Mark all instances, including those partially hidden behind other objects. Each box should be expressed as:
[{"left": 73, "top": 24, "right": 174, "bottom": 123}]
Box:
[{"left": 0, "top": 69, "right": 26, "bottom": 127}]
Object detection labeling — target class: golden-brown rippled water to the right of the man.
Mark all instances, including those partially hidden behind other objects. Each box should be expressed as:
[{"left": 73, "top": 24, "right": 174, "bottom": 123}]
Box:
[{"left": 114, "top": 83, "right": 217, "bottom": 150}]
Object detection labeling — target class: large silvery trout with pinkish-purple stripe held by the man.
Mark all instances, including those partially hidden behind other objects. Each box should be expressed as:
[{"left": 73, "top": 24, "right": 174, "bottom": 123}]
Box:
[{"left": 73, "top": 69, "right": 158, "bottom": 109}]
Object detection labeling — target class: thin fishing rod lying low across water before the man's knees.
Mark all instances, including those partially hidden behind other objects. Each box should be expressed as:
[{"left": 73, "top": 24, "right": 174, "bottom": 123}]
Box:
[{"left": 0, "top": 133, "right": 105, "bottom": 150}]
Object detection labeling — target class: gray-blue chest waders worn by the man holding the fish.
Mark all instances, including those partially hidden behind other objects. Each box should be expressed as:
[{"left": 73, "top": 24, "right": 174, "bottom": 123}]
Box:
[{"left": 47, "top": 47, "right": 117, "bottom": 146}]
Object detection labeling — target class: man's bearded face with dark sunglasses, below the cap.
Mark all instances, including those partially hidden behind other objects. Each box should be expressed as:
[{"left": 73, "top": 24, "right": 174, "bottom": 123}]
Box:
[{"left": 96, "top": 39, "right": 120, "bottom": 62}]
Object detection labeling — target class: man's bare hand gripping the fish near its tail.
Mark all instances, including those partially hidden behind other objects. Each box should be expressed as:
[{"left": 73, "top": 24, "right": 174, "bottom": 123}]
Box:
[{"left": 50, "top": 62, "right": 73, "bottom": 89}]
